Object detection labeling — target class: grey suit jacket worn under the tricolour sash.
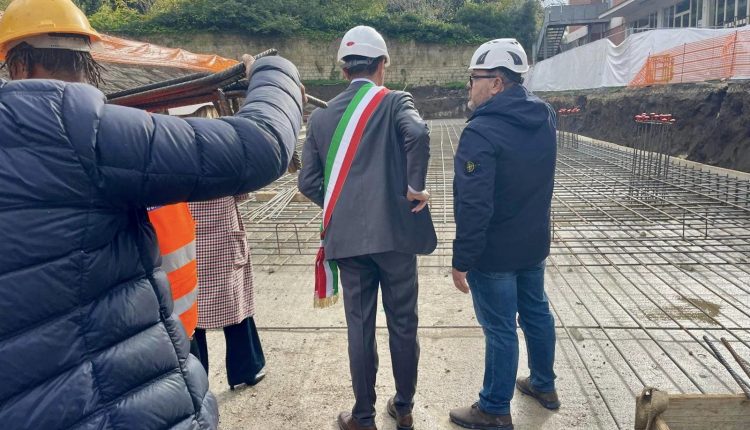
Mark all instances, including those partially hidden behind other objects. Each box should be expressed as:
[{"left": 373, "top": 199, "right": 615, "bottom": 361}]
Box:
[{"left": 299, "top": 81, "right": 437, "bottom": 259}]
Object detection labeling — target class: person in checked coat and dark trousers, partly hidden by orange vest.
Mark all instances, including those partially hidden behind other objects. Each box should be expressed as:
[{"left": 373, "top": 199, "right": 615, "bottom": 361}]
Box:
[{"left": 190, "top": 194, "right": 266, "bottom": 389}]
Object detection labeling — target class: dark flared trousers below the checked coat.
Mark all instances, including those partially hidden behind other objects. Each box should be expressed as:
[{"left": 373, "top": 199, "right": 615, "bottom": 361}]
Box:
[{"left": 190, "top": 317, "right": 266, "bottom": 385}]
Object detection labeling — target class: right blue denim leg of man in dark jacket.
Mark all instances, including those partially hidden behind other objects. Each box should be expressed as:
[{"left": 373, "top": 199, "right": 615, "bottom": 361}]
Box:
[{"left": 517, "top": 262, "right": 555, "bottom": 392}]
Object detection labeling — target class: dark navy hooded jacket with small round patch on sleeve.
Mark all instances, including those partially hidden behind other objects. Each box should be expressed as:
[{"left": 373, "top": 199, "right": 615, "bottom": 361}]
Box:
[{"left": 453, "top": 85, "right": 557, "bottom": 272}]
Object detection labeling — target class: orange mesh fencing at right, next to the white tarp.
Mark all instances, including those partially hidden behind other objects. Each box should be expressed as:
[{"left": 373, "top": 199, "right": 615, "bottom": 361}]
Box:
[{"left": 628, "top": 29, "right": 750, "bottom": 87}]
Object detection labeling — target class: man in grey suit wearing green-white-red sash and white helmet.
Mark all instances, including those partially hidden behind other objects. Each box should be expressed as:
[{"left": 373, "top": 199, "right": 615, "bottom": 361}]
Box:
[{"left": 299, "top": 26, "right": 437, "bottom": 430}]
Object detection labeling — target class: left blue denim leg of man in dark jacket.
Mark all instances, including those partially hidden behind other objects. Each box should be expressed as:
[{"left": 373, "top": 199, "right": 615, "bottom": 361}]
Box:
[{"left": 467, "top": 270, "right": 518, "bottom": 415}]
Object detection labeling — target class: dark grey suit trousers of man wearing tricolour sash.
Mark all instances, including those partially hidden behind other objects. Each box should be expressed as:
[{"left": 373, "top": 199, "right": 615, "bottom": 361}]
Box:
[{"left": 336, "top": 252, "right": 419, "bottom": 426}]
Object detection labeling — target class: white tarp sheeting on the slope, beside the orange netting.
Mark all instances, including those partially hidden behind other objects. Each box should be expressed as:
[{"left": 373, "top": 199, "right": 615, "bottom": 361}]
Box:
[{"left": 526, "top": 28, "right": 750, "bottom": 91}]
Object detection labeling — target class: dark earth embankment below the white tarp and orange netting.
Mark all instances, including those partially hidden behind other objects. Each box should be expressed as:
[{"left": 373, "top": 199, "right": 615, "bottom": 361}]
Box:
[{"left": 539, "top": 82, "right": 750, "bottom": 172}]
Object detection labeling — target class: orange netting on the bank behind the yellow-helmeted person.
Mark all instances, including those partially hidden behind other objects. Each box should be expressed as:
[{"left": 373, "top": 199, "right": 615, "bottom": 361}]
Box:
[{"left": 0, "top": 11, "right": 238, "bottom": 72}]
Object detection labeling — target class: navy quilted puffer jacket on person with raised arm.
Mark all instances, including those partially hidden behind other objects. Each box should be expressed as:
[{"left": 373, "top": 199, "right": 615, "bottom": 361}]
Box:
[{"left": 0, "top": 57, "right": 302, "bottom": 430}]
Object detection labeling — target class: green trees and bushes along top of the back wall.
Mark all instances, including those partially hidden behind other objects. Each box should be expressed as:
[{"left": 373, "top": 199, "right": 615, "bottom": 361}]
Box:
[{"left": 78, "top": 0, "right": 540, "bottom": 49}]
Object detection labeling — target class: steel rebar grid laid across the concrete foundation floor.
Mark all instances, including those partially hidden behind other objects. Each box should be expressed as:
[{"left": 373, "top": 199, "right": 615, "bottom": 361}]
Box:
[{"left": 241, "top": 120, "right": 750, "bottom": 428}]
